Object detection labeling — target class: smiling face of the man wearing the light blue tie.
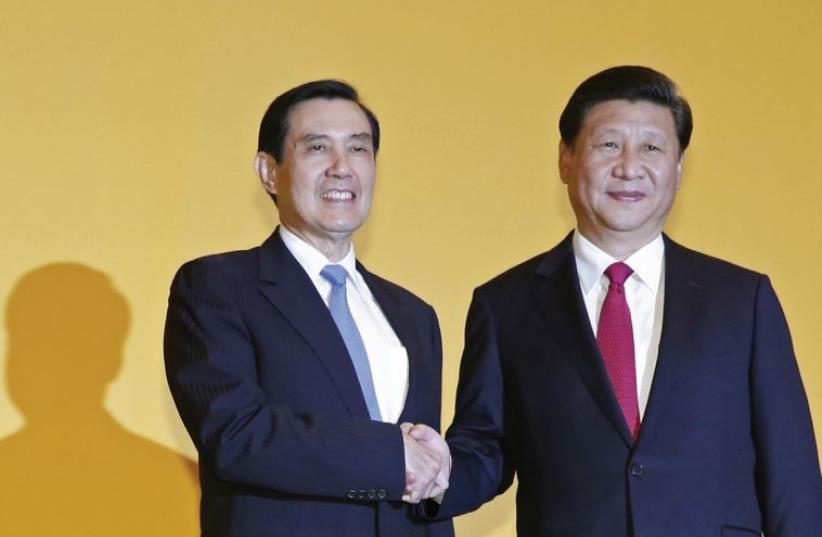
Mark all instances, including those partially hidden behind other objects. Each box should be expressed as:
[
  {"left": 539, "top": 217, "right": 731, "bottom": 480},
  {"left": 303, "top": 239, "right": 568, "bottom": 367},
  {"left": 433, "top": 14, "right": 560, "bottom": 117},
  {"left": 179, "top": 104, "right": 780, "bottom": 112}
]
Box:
[{"left": 255, "top": 99, "right": 376, "bottom": 261}]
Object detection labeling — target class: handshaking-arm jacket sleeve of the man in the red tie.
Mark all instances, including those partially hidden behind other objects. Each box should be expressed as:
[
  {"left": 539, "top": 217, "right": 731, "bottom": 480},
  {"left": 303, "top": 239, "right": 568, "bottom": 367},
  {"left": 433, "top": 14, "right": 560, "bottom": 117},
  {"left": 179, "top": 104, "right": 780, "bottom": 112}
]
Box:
[{"left": 427, "top": 290, "right": 514, "bottom": 518}]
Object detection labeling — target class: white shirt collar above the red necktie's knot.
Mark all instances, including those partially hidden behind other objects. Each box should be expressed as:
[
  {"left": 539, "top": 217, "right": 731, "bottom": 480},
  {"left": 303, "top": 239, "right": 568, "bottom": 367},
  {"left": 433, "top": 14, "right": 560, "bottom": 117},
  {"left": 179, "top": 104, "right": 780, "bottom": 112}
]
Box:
[{"left": 572, "top": 230, "right": 665, "bottom": 294}]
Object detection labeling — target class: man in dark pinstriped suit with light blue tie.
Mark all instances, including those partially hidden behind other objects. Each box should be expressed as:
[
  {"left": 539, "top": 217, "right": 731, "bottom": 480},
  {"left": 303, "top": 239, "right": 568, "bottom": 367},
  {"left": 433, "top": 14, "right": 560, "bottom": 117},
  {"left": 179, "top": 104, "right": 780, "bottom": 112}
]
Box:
[{"left": 165, "top": 80, "right": 453, "bottom": 537}]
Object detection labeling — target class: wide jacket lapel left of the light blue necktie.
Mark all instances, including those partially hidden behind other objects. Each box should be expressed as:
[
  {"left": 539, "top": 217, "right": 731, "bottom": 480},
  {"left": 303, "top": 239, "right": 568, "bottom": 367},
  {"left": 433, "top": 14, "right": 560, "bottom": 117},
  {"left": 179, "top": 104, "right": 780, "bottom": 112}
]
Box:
[{"left": 259, "top": 230, "right": 368, "bottom": 418}]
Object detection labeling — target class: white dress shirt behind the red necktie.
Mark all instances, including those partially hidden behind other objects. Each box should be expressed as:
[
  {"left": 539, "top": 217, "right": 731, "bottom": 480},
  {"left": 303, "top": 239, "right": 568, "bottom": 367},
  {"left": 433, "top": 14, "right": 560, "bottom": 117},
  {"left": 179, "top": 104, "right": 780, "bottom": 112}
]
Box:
[{"left": 573, "top": 230, "right": 665, "bottom": 418}]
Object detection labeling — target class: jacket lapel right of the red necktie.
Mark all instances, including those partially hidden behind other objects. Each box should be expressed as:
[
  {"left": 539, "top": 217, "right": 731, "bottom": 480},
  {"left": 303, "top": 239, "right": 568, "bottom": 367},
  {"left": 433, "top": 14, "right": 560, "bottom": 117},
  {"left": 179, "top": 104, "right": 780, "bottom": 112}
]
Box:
[{"left": 639, "top": 236, "right": 706, "bottom": 441}]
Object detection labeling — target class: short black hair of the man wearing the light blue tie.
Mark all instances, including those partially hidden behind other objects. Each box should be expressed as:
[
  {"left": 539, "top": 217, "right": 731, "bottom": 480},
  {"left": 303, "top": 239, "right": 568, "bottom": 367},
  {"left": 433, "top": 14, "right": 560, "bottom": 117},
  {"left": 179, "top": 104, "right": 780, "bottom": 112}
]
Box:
[{"left": 257, "top": 80, "right": 380, "bottom": 163}]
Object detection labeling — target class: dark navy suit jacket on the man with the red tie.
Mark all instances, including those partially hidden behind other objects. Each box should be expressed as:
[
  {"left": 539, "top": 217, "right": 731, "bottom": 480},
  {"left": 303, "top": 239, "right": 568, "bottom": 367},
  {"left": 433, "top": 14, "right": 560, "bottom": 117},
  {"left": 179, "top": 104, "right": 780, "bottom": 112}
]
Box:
[{"left": 429, "top": 235, "right": 822, "bottom": 537}]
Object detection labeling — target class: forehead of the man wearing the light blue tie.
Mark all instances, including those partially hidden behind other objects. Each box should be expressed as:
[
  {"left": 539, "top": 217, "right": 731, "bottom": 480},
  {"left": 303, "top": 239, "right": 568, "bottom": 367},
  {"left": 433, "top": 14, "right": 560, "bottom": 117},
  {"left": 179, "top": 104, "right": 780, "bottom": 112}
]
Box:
[{"left": 288, "top": 98, "right": 371, "bottom": 139}]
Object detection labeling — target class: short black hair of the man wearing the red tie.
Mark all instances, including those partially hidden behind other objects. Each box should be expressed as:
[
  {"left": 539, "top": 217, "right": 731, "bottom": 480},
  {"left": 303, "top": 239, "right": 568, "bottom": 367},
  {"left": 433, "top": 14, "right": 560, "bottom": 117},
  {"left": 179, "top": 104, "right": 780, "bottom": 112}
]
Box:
[{"left": 559, "top": 65, "right": 694, "bottom": 153}]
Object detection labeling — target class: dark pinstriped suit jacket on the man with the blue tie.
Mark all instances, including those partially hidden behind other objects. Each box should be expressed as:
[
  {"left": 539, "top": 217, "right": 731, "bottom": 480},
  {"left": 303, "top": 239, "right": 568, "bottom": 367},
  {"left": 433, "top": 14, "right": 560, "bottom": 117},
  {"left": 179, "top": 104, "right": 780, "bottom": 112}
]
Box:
[{"left": 165, "top": 231, "right": 453, "bottom": 537}]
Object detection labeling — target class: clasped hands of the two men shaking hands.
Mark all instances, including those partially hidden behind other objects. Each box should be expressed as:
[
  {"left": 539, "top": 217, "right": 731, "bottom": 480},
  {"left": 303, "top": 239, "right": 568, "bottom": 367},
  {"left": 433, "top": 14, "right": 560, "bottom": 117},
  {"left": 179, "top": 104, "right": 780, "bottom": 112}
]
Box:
[{"left": 400, "top": 423, "right": 451, "bottom": 503}]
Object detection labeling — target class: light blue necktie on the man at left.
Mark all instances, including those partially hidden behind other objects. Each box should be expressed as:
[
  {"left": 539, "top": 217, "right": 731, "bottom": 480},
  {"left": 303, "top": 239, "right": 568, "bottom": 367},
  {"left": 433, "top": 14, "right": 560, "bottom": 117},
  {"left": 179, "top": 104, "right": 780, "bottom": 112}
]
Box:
[{"left": 320, "top": 265, "right": 382, "bottom": 421}]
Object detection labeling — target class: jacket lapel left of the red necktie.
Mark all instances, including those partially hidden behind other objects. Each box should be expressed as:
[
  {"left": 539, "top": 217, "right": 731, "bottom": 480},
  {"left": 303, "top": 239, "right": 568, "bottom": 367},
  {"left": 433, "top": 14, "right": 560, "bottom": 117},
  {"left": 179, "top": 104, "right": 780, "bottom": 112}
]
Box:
[{"left": 532, "top": 234, "right": 633, "bottom": 446}]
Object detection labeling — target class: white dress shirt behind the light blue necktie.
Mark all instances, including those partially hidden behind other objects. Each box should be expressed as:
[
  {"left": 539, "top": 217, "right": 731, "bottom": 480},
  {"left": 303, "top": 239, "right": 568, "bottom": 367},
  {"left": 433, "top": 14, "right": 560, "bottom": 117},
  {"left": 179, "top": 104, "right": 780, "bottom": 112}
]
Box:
[{"left": 280, "top": 226, "right": 408, "bottom": 423}]
